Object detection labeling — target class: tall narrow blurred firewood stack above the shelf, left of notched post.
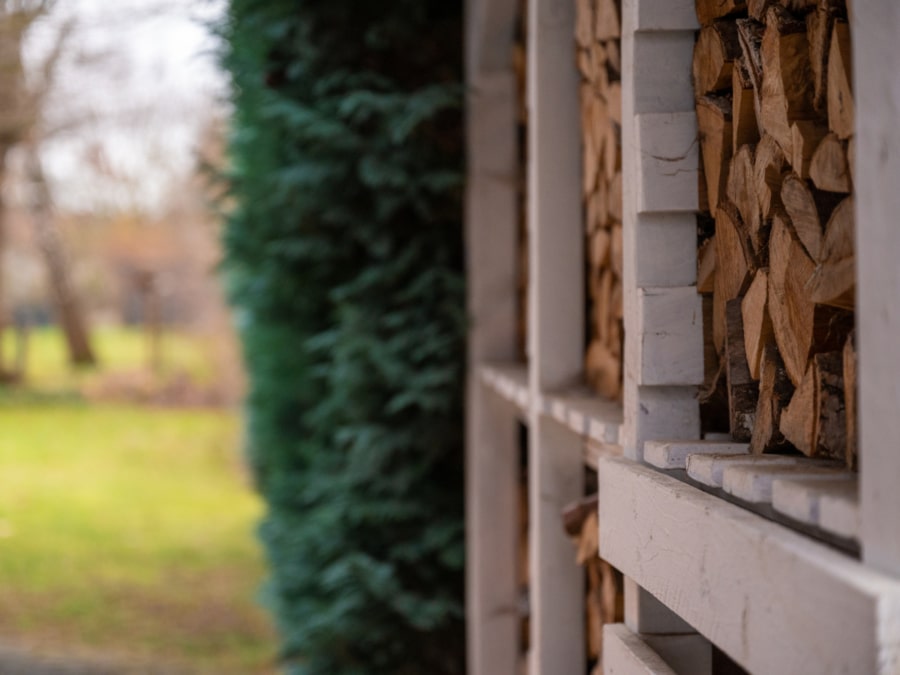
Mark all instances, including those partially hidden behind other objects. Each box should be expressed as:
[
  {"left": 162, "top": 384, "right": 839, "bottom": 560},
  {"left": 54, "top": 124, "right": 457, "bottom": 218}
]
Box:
[{"left": 575, "top": 0, "right": 623, "bottom": 399}]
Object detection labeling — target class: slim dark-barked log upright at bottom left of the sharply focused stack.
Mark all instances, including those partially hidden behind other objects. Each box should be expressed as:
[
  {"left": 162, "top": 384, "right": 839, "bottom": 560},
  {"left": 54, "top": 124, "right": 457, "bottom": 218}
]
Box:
[{"left": 725, "top": 298, "right": 759, "bottom": 442}]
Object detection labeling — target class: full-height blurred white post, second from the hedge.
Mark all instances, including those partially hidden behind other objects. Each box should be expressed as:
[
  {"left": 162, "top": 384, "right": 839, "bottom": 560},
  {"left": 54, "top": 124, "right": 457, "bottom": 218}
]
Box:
[{"left": 526, "top": 0, "right": 585, "bottom": 674}]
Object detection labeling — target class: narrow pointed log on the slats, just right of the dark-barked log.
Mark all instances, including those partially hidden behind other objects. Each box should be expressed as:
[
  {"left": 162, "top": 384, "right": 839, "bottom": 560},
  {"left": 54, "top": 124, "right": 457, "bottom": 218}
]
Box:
[{"left": 750, "top": 339, "right": 794, "bottom": 454}]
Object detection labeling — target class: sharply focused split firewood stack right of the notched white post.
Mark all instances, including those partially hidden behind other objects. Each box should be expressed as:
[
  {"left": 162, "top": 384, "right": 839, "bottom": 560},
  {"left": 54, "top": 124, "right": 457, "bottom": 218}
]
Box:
[{"left": 693, "top": 0, "right": 856, "bottom": 466}]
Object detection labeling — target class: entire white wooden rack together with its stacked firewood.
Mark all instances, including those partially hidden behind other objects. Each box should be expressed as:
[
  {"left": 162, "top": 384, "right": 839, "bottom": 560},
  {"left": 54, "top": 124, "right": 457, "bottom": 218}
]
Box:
[{"left": 467, "top": 0, "right": 900, "bottom": 675}]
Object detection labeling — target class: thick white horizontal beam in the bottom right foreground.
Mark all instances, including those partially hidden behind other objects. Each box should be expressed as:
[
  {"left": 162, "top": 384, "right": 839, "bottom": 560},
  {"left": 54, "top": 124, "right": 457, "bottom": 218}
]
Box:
[{"left": 598, "top": 458, "right": 900, "bottom": 675}]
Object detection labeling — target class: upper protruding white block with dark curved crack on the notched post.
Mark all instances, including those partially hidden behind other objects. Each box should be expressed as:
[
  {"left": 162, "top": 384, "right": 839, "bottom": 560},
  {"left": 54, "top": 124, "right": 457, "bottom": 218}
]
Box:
[{"left": 637, "top": 112, "right": 700, "bottom": 213}]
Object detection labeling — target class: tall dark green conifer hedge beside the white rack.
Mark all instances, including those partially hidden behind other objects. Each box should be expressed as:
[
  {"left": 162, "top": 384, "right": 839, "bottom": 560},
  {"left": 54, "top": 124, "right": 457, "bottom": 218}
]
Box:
[{"left": 222, "top": 0, "right": 465, "bottom": 675}]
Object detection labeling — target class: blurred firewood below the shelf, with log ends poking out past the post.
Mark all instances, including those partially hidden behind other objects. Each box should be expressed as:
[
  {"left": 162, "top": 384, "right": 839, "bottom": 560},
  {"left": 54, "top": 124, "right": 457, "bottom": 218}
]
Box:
[{"left": 563, "top": 494, "right": 625, "bottom": 675}]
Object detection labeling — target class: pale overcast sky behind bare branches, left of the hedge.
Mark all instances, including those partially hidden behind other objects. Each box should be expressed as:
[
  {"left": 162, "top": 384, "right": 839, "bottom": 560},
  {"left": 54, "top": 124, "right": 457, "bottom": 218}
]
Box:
[{"left": 26, "top": 0, "right": 225, "bottom": 214}]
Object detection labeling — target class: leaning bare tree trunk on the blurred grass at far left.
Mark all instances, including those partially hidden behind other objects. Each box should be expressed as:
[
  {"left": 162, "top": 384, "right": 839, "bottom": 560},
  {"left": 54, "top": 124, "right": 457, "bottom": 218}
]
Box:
[{"left": 27, "top": 143, "right": 97, "bottom": 365}]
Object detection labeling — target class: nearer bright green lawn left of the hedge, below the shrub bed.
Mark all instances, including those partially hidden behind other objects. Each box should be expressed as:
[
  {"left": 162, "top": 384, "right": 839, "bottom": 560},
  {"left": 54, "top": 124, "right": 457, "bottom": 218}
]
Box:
[{"left": 0, "top": 401, "right": 275, "bottom": 674}]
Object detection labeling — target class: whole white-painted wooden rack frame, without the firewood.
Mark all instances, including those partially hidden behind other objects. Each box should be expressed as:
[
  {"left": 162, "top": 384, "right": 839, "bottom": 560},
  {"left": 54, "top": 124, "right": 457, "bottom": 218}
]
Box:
[{"left": 466, "top": 0, "right": 900, "bottom": 675}]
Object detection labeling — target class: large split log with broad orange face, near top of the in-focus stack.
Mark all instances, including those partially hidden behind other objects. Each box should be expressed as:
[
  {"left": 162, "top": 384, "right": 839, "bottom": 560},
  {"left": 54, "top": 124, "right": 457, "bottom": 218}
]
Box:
[{"left": 759, "top": 5, "right": 816, "bottom": 157}]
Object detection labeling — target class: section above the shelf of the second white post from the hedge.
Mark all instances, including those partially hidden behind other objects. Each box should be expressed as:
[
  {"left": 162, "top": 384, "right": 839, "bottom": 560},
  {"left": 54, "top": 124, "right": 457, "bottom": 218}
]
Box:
[{"left": 527, "top": 0, "right": 585, "bottom": 394}]
